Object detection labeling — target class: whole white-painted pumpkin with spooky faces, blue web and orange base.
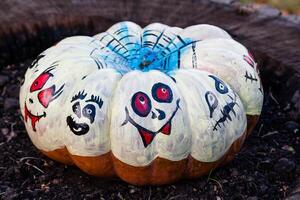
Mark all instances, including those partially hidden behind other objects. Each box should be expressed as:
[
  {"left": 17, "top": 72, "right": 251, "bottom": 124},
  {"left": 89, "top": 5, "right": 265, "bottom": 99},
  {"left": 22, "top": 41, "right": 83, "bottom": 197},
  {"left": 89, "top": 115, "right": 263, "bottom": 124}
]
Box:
[{"left": 20, "top": 22, "right": 263, "bottom": 185}]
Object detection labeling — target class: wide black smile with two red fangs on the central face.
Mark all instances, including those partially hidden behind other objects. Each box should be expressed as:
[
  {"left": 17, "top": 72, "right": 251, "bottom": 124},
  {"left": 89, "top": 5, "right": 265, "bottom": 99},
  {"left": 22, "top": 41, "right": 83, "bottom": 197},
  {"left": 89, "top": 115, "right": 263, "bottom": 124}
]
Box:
[{"left": 121, "top": 99, "right": 180, "bottom": 148}]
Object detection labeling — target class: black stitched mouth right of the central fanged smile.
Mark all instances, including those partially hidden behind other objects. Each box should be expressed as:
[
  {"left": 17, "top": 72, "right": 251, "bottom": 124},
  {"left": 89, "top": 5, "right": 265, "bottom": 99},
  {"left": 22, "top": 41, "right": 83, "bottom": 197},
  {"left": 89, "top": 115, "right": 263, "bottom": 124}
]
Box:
[{"left": 213, "top": 94, "right": 238, "bottom": 131}]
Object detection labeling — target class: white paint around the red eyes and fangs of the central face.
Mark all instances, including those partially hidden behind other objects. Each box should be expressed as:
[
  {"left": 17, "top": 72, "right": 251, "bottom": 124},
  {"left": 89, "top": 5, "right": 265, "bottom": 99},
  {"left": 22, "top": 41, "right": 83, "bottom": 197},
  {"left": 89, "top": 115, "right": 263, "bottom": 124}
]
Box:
[{"left": 110, "top": 70, "right": 191, "bottom": 166}]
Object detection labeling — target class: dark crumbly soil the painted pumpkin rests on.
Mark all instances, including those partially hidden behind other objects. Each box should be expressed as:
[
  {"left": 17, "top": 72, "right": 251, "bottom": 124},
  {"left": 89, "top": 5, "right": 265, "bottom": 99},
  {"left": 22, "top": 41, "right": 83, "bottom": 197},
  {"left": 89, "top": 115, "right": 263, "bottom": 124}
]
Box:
[{"left": 0, "top": 60, "right": 300, "bottom": 200}]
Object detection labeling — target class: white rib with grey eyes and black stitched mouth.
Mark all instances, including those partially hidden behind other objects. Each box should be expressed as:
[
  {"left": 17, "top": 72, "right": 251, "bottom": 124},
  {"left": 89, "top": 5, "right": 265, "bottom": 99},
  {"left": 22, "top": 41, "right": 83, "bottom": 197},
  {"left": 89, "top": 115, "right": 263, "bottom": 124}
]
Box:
[{"left": 173, "top": 69, "right": 247, "bottom": 162}]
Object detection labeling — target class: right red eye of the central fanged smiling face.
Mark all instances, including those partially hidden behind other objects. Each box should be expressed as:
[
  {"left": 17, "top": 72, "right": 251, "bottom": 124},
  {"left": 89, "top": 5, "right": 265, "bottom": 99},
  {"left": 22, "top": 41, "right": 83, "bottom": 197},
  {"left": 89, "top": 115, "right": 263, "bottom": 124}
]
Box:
[{"left": 152, "top": 83, "right": 173, "bottom": 103}]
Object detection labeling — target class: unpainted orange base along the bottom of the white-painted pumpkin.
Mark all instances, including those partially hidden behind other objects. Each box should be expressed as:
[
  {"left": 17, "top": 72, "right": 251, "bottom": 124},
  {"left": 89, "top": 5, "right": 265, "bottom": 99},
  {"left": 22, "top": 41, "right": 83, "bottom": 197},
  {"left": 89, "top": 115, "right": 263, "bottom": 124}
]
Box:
[{"left": 42, "top": 116, "right": 259, "bottom": 185}]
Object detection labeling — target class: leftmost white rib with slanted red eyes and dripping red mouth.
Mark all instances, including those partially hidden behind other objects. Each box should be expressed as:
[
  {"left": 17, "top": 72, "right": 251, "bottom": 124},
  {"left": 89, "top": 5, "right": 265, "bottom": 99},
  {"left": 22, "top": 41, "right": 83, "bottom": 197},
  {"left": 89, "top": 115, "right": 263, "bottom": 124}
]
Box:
[{"left": 20, "top": 38, "right": 107, "bottom": 151}]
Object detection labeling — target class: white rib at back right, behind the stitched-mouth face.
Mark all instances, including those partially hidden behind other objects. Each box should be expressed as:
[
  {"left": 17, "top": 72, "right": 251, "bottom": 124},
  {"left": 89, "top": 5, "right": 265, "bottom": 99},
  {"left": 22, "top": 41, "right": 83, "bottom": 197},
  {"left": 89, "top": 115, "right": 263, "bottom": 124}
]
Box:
[{"left": 181, "top": 39, "right": 263, "bottom": 115}]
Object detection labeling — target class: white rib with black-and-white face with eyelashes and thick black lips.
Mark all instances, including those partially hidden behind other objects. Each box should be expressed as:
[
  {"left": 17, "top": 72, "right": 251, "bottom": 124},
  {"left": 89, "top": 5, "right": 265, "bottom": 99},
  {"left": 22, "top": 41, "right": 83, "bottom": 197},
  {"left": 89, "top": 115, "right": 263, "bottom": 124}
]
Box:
[{"left": 64, "top": 69, "right": 121, "bottom": 156}]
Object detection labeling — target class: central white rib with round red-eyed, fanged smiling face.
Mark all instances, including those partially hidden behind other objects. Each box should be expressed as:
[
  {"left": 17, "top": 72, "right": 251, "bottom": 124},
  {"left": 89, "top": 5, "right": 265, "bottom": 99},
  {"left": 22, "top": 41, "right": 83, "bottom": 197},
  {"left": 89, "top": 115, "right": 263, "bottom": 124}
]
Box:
[{"left": 111, "top": 70, "right": 190, "bottom": 165}]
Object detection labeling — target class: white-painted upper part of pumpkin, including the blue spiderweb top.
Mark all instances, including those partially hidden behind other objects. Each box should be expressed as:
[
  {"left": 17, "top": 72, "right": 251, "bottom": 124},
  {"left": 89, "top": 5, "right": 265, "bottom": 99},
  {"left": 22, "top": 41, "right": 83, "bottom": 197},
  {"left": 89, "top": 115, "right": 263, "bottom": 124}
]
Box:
[{"left": 20, "top": 22, "right": 263, "bottom": 166}]
